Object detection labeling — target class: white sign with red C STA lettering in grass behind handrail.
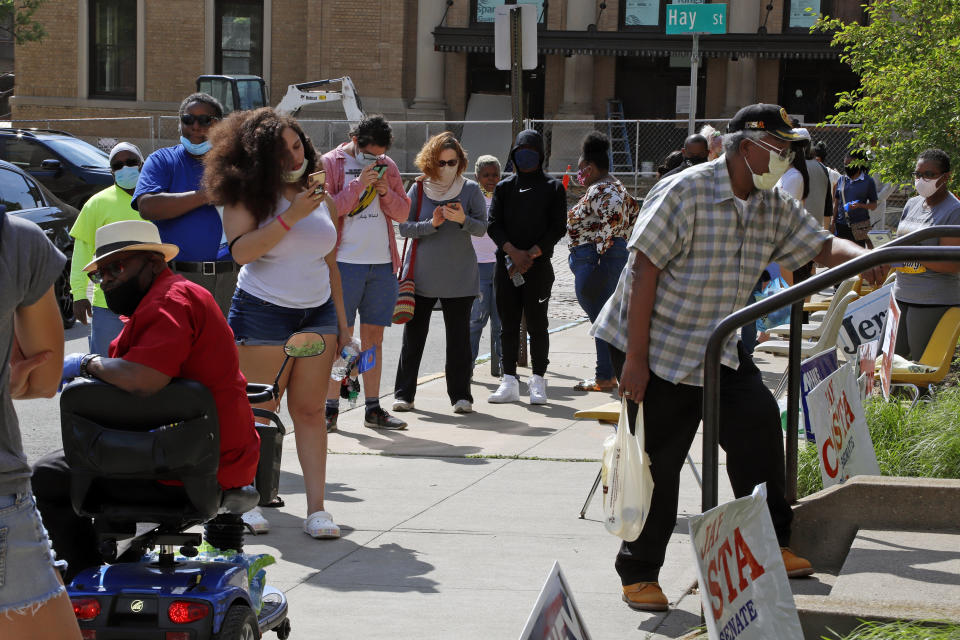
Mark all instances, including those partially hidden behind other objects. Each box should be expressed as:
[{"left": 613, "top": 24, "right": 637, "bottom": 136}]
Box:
[{"left": 807, "top": 360, "right": 880, "bottom": 487}]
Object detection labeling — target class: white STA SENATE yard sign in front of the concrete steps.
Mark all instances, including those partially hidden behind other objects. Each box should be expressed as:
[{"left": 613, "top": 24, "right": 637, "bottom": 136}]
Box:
[{"left": 689, "top": 484, "right": 803, "bottom": 640}]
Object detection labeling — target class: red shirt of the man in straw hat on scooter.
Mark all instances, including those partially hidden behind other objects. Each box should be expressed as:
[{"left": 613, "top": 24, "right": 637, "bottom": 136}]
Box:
[{"left": 110, "top": 269, "right": 260, "bottom": 489}]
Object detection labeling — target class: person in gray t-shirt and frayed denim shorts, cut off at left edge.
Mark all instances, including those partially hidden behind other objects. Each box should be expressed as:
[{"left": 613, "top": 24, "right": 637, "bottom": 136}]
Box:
[{"left": 0, "top": 212, "right": 80, "bottom": 639}]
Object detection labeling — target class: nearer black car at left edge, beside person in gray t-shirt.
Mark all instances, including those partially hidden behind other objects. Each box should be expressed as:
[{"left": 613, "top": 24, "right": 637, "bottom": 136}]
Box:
[{"left": 0, "top": 160, "right": 77, "bottom": 328}]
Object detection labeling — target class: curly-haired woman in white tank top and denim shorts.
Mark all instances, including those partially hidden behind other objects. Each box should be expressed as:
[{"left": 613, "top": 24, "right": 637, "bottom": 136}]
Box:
[{"left": 204, "top": 107, "right": 350, "bottom": 538}]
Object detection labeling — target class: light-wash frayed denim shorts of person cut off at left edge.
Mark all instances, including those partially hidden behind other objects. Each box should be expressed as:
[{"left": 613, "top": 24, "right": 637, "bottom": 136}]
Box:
[{"left": 0, "top": 491, "right": 63, "bottom": 615}]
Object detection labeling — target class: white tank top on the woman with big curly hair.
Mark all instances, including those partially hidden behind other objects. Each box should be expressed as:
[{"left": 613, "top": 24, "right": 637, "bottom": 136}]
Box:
[{"left": 237, "top": 197, "right": 337, "bottom": 309}]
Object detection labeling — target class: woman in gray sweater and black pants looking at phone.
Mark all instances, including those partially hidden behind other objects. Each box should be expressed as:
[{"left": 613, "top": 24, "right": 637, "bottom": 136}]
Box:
[{"left": 393, "top": 131, "right": 487, "bottom": 413}]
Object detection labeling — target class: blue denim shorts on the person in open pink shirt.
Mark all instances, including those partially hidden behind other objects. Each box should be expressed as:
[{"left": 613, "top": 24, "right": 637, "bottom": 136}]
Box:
[{"left": 337, "top": 262, "right": 399, "bottom": 327}]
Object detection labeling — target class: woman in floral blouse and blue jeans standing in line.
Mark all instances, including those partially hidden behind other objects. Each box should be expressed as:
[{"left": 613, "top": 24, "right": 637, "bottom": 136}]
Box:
[{"left": 567, "top": 132, "right": 640, "bottom": 391}]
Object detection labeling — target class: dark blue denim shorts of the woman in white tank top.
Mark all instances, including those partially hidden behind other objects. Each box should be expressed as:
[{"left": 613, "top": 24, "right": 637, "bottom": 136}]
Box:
[{"left": 227, "top": 288, "right": 337, "bottom": 346}]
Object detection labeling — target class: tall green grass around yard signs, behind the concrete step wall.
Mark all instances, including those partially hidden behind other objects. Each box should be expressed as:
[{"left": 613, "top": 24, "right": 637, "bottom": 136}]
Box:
[{"left": 797, "top": 387, "right": 960, "bottom": 496}]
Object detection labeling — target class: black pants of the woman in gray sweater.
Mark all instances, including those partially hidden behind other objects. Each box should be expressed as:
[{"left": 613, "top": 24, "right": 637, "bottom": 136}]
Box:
[{"left": 393, "top": 295, "right": 475, "bottom": 404}]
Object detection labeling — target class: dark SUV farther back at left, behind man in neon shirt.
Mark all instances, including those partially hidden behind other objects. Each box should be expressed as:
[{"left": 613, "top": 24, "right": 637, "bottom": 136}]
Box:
[{"left": 0, "top": 129, "right": 113, "bottom": 209}]
